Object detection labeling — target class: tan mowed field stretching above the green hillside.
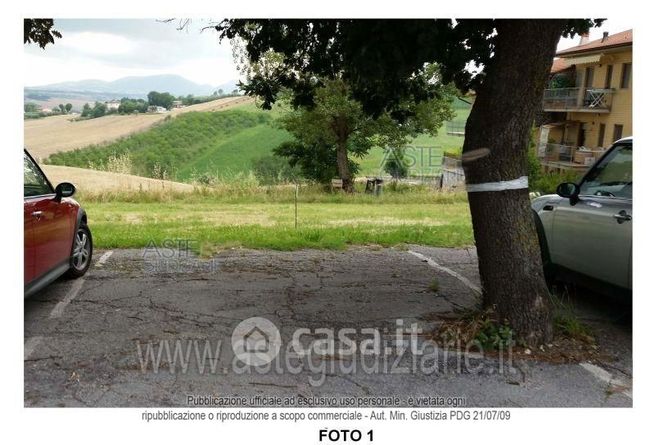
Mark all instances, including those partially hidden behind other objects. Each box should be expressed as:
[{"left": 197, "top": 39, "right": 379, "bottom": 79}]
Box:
[{"left": 24, "top": 97, "right": 253, "bottom": 161}]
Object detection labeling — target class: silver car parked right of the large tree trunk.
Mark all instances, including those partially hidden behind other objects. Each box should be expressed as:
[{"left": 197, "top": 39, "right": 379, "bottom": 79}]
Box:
[{"left": 532, "top": 137, "right": 632, "bottom": 292}]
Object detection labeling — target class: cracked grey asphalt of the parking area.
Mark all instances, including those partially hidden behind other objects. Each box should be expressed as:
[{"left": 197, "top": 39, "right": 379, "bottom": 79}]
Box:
[{"left": 24, "top": 246, "right": 632, "bottom": 407}]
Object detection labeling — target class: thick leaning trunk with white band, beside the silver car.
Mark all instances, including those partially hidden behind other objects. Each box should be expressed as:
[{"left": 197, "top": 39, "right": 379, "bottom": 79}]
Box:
[{"left": 463, "top": 20, "right": 565, "bottom": 346}]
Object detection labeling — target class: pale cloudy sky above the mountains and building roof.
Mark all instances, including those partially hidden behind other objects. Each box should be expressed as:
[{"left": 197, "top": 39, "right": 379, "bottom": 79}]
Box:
[{"left": 24, "top": 19, "right": 631, "bottom": 86}]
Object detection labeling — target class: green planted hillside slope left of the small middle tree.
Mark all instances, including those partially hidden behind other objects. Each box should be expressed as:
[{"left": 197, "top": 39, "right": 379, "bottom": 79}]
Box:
[{"left": 47, "top": 110, "right": 289, "bottom": 181}]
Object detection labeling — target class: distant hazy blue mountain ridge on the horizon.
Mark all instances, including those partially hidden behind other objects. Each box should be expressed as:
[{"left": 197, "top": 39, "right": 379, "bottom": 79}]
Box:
[{"left": 25, "top": 74, "right": 237, "bottom": 97}]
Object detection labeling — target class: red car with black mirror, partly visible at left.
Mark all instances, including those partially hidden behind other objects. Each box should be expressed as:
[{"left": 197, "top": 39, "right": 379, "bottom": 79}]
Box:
[{"left": 23, "top": 150, "right": 93, "bottom": 298}]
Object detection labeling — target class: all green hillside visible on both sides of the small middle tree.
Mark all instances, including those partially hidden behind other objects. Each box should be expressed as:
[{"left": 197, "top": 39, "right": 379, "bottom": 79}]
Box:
[{"left": 46, "top": 100, "right": 469, "bottom": 182}]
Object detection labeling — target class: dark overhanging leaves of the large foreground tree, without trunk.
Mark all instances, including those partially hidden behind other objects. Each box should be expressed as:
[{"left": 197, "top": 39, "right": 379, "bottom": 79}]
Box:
[{"left": 216, "top": 19, "right": 602, "bottom": 115}]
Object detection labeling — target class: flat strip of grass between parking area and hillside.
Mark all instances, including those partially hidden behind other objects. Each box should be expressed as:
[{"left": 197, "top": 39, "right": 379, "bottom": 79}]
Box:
[{"left": 81, "top": 187, "right": 473, "bottom": 253}]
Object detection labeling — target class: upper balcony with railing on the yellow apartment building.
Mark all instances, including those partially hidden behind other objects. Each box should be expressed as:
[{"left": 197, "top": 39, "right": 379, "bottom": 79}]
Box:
[{"left": 543, "top": 88, "right": 612, "bottom": 113}]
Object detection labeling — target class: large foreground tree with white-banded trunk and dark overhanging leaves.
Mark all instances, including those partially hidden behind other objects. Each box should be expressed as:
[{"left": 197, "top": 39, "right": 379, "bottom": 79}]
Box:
[{"left": 216, "top": 19, "right": 602, "bottom": 345}]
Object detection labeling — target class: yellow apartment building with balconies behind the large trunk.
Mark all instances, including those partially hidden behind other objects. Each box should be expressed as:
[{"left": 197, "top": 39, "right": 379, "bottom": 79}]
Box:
[{"left": 536, "top": 30, "right": 632, "bottom": 171}]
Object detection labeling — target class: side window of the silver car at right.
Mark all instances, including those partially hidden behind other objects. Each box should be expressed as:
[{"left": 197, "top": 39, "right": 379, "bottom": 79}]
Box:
[{"left": 580, "top": 143, "right": 632, "bottom": 199}]
